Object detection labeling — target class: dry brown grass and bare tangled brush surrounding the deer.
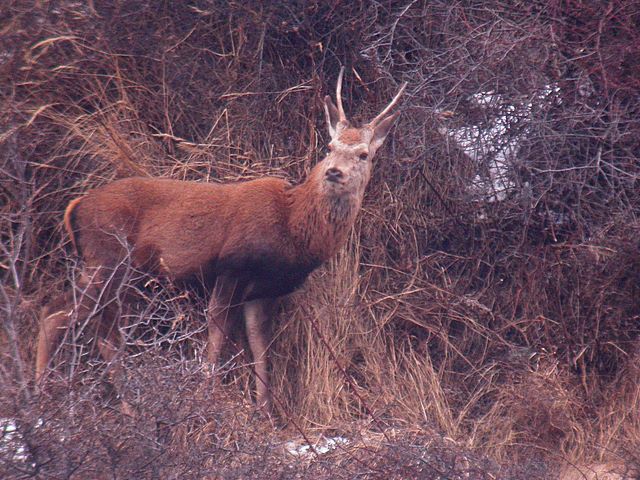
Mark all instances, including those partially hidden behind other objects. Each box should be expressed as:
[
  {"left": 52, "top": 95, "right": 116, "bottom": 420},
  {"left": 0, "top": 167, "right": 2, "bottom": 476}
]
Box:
[{"left": 0, "top": 0, "right": 640, "bottom": 478}]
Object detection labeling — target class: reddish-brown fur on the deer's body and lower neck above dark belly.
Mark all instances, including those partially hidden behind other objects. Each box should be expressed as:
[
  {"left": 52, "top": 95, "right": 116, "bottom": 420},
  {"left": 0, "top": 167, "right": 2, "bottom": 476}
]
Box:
[{"left": 65, "top": 174, "right": 344, "bottom": 286}]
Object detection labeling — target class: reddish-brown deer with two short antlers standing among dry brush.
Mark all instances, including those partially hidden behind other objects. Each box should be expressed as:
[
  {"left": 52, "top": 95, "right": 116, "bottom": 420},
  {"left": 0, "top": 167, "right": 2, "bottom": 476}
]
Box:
[{"left": 35, "top": 67, "right": 407, "bottom": 412}]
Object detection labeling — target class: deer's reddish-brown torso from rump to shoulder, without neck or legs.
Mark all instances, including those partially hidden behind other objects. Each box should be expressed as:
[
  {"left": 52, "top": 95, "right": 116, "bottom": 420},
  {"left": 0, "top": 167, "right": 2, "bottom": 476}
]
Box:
[{"left": 67, "top": 178, "right": 317, "bottom": 296}]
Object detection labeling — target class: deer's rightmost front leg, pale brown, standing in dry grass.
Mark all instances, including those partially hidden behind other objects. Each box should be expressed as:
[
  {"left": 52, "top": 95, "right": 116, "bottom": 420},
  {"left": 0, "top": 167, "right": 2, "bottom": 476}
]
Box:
[{"left": 244, "top": 299, "right": 273, "bottom": 411}]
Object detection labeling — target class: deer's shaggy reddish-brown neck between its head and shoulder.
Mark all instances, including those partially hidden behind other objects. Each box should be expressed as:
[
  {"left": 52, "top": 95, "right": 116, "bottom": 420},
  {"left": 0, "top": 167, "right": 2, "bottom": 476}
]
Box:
[{"left": 289, "top": 169, "right": 363, "bottom": 263}]
